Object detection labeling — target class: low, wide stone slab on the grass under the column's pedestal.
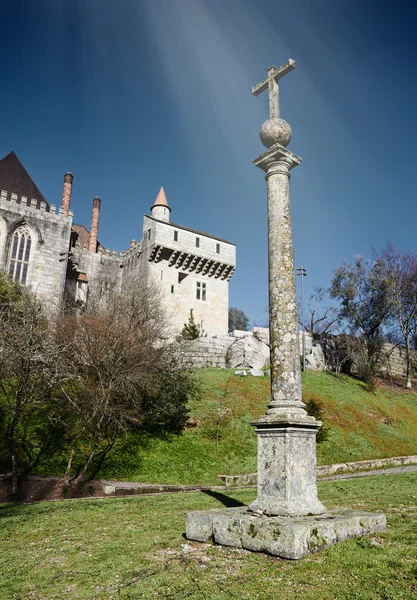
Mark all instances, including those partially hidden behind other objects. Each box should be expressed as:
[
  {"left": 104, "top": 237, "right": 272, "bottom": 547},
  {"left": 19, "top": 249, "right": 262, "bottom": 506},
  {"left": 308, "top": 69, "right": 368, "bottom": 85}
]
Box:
[{"left": 186, "top": 507, "right": 386, "bottom": 560}]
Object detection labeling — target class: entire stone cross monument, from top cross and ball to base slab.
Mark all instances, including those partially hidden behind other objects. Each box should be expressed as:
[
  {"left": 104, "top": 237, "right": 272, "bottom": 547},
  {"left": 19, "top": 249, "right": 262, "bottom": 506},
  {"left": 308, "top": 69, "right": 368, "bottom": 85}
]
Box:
[{"left": 186, "top": 60, "right": 386, "bottom": 559}]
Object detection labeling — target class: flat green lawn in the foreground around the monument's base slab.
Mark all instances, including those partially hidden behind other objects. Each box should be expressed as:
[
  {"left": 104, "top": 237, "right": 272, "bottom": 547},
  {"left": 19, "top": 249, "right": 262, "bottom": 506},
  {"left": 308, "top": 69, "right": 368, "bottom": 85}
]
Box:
[{"left": 0, "top": 473, "right": 417, "bottom": 600}]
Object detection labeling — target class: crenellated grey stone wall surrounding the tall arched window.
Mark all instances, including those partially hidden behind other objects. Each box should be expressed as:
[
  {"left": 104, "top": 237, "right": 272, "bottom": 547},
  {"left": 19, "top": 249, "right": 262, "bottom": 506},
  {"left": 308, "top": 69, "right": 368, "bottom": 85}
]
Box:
[{"left": 0, "top": 190, "right": 72, "bottom": 310}]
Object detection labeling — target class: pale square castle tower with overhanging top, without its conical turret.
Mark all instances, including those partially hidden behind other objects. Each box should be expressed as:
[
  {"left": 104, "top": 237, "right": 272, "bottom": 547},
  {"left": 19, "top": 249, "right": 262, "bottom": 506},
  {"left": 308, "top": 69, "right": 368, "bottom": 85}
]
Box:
[{"left": 135, "top": 216, "right": 236, "bottom": 336}]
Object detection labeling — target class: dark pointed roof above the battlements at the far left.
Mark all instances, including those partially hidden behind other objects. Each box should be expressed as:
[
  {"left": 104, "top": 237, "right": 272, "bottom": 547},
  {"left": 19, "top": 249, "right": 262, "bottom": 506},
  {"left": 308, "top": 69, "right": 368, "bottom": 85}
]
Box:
[{"left": 0, "top": 152, "right": 49, "bottom": 211}]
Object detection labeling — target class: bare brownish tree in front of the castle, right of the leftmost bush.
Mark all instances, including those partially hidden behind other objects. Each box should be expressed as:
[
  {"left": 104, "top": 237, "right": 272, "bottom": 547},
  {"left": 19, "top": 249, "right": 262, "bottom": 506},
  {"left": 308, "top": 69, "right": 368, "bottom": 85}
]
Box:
[{"left": 59, "top": 285, "right": 194, "bottom": 483}]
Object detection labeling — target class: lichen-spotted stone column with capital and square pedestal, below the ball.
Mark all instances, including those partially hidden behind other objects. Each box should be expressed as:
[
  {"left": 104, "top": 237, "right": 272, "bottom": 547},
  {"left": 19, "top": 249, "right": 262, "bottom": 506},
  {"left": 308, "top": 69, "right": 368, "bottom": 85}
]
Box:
[{"left": 249, "top": 139, "right": 326, "bottom": 516}]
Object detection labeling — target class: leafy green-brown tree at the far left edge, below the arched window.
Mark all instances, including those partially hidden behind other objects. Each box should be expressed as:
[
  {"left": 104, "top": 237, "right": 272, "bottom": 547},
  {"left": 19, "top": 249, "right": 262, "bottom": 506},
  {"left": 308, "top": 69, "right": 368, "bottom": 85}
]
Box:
[{"left": 0, "top": 284, "right": 62, "bottom": 494}]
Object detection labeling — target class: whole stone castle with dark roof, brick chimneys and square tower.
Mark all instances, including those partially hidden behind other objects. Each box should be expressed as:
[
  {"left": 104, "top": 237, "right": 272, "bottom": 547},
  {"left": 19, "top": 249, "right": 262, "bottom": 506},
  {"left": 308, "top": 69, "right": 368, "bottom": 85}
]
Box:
[{"left": 0, "top": 152, "right": 236, "bottom": 336}]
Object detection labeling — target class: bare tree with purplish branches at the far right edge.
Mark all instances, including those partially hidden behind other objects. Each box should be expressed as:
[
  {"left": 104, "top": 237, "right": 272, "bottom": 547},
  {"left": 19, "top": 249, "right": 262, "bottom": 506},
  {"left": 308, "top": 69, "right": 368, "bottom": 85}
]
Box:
[{"left": 381, "top": 244, "right": 417, "bottom": 389}]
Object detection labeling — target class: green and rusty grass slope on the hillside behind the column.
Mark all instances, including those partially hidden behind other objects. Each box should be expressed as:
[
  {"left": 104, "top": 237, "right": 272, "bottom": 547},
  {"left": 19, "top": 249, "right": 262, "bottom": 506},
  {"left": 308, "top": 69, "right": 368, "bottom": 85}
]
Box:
[{"left": 96, "top": 369, "right": 417, "bottom": 484}]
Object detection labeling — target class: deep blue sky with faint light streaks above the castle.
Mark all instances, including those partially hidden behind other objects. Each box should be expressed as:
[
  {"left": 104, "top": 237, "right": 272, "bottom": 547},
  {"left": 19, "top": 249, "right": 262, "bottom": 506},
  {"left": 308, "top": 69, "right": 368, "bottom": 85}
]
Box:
[{"left": 0, "top": 0, "right": 417, "bottom": 322}]
